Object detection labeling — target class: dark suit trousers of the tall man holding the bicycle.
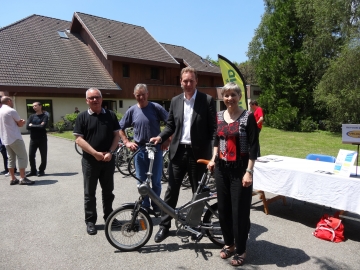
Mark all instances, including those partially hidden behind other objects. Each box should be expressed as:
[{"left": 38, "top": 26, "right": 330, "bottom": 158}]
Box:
[{"left": 160, "top": 145, "right": 206, "bottom": 228}]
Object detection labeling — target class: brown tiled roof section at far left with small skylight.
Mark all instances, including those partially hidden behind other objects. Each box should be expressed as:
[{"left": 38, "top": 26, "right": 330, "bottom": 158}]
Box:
[{"left": 0, "top": 15, "right": 119, "bottom": 90}]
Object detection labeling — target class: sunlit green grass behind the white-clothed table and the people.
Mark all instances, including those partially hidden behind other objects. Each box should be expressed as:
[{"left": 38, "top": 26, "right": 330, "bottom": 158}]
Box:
[{"left": 49, "top": 127, "right": 357, "bottom": 158}]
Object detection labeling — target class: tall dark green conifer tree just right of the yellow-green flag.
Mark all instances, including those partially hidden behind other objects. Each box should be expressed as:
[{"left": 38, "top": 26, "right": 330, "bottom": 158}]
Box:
[{"left": 248, "top": 0, "right": 312, "bottom": 130}]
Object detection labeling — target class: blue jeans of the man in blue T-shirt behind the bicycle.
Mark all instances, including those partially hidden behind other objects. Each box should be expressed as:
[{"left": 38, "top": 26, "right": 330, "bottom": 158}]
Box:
[{"left": 134, "top": 145, "right": 163, "bottom": 210}]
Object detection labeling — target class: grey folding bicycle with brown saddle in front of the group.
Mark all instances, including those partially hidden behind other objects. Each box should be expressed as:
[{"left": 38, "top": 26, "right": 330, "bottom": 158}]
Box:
[{"left": 105, "top": 143, "right": 224, "bottom": 251}]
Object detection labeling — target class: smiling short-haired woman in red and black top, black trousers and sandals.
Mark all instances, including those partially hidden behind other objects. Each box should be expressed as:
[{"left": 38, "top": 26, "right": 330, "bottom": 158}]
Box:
[{"left": 207, "top": 82, "right": 259, "bottom": 266}]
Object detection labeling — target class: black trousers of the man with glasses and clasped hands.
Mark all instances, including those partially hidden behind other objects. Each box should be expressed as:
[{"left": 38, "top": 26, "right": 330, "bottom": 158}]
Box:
[{"left": 81, "top": 157, "right": 115, "bottom": 224}]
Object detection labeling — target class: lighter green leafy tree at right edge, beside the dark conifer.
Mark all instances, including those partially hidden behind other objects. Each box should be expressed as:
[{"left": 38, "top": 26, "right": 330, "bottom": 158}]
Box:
[{"left": 296, "top": 0, "right": 360, "bottom": 131}]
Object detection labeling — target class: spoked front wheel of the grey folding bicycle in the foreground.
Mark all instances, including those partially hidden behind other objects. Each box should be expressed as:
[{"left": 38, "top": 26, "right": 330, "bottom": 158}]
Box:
[{"left": 105, "top": 205, "right": 153, "bottom": 251}]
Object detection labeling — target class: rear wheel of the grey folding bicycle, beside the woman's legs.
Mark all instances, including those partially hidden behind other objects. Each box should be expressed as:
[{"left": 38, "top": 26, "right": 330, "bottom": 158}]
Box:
[{"left": 203, "top": 203, "right": 225, "bottom": 247}]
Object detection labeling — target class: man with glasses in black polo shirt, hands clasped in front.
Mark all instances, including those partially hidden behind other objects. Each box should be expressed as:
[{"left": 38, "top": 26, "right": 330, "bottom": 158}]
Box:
[{"left": 74, "top": 88, "right": 120, "bottom": 235}]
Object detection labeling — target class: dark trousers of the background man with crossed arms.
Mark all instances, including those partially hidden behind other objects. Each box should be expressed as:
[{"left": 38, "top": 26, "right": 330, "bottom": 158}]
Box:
[{"left": 29, "top": 136, "right": 47, "bottom": 173}]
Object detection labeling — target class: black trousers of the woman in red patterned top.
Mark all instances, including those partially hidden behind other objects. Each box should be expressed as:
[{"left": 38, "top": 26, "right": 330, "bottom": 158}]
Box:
[{"left": 215, "top": 162, "right": 253, "bottom": 254}]
